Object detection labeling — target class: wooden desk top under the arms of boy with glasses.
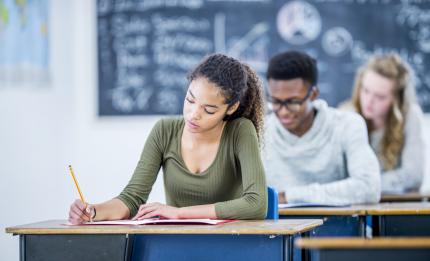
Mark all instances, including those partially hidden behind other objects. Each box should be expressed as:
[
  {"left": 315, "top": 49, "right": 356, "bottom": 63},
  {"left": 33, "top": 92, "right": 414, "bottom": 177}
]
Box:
[{"left": 279, "top": 206, "right": 366, "bottom": 216}]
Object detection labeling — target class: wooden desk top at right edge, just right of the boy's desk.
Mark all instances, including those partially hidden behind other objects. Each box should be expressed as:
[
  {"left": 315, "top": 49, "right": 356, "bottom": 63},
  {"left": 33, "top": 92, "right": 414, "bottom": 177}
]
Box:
[{"left": 366, "top": 202, "right": 430, "bottom": 215}]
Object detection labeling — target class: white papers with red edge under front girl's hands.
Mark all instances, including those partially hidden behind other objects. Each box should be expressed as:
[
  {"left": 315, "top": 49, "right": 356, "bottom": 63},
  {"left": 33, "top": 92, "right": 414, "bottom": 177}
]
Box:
[{"left": 67, "top": 218, "right": 234, "bottom": 225}]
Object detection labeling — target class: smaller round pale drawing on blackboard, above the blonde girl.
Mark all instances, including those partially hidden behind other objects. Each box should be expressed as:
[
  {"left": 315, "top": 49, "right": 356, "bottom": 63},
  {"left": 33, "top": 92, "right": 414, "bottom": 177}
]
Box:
[{"left": 322, "top": 27, "right": 353, "bottom": 56}]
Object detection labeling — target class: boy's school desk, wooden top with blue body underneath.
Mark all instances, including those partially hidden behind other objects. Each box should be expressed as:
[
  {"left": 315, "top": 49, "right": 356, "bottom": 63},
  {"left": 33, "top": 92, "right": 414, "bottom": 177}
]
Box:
[{"left": 279, "top": 205, "right": 366, "bottom": 237}]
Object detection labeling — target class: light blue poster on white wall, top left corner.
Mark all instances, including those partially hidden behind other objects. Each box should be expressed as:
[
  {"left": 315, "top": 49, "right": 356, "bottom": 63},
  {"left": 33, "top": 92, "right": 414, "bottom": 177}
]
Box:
[{"left": 0, "top": 0, "right": 49, "bottom": 88}]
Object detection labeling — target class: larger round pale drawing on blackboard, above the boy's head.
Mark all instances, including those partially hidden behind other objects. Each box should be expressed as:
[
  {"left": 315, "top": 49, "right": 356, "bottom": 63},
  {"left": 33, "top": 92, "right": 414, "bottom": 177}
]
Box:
[{"left": 276, "top": 1, "right": 321, "bottom": 45}]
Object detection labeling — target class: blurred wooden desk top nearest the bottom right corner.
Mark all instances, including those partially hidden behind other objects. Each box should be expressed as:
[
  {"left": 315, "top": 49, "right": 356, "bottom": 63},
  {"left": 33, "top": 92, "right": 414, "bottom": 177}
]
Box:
[{"left": 295, "top": 237, "right": 430, "bottom": 249}]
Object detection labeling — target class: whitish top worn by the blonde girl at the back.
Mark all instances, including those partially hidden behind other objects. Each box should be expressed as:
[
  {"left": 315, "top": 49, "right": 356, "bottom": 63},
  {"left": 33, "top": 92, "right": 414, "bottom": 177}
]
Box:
[{"left": 370, "top": 104, "right": 426, "bottom": 192}]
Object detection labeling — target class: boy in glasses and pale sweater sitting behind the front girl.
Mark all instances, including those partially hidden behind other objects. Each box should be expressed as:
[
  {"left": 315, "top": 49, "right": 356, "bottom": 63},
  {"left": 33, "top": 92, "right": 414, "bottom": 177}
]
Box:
[{"left": 264, "top": 51, "right": 381, "bottom": 204}]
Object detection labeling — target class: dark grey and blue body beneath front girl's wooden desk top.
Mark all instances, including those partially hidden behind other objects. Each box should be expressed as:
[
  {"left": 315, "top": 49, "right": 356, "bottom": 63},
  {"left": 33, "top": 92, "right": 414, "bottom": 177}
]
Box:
[{"left": 20, "top": 234, "right": 305, "bottom": 261}]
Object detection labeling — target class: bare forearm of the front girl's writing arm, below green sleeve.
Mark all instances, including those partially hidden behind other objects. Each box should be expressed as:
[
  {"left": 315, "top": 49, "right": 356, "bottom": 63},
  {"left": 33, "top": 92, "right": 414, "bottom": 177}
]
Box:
[{"left": 93, "top": 198, "right": 130, "bottom": 221}]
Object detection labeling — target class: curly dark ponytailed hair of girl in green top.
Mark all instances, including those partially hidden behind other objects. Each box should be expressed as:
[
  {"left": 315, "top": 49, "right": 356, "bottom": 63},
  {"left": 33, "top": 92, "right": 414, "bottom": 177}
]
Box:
[{"left": 188, "top": 54, "right": 264, "bottom": 142}]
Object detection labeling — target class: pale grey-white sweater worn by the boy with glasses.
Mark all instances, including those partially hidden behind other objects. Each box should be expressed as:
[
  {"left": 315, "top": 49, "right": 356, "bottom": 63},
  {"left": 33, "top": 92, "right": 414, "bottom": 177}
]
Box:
[{"left": 263, "top": 100, "right": 381, "bottom": 204}]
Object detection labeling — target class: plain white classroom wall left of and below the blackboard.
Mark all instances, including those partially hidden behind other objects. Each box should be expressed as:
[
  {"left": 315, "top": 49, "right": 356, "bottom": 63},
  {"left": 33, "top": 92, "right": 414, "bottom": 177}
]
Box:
[{"left": 0, "top": 0, "right": 430, "bottom": 260}]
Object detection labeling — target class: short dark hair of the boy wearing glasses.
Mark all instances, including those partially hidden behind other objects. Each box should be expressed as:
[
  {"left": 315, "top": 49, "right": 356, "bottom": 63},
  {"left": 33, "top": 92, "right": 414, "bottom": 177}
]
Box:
[{"left": 266, "top": 51, "right": 318, "bottom": 86}]
